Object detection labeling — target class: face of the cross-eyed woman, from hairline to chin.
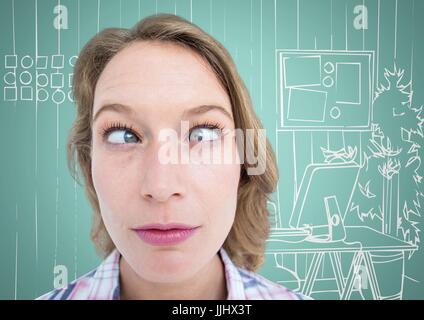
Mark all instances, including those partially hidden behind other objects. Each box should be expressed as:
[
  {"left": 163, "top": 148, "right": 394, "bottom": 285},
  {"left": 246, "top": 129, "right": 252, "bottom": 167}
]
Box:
[{"left": 92, "top": 41, "right": 240, "bottom": 282}]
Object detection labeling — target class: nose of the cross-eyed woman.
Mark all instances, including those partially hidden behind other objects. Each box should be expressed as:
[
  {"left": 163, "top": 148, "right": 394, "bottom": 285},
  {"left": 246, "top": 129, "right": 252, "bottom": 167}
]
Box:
[{"left": 140, "top": 142, "right": 186, "bottom": 203}]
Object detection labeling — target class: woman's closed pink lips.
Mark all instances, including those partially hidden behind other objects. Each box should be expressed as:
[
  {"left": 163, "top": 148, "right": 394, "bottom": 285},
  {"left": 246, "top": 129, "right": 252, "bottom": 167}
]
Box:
[{"left": 133, "top": 223, "right": 198, "bottom": 246}]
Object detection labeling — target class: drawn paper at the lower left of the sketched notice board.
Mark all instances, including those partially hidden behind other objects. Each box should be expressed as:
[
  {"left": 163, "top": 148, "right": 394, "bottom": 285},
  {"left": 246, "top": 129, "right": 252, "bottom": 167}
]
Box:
[{"left": 288, "top": 88, "right": 327, "bottom": 122}]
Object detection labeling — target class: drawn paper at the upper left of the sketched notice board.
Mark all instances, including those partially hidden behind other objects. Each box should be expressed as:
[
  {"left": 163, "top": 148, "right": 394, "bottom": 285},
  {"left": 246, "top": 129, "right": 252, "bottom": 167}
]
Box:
[{"left": 284, "top": 56, "right": 321, "bottom": 88}]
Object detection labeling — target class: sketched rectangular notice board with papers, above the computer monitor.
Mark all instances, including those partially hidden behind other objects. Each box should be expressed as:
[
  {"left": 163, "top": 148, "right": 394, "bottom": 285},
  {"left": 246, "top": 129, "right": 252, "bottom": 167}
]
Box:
[{"left": 276, "top": 50, "right": 374, "bottom": 130}]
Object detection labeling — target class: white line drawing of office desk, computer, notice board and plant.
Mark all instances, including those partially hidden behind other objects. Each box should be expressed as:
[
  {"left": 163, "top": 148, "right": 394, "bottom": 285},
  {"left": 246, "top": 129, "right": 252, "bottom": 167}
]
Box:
[{"left": 264, "top": 49, "right": 424, "bottom": 299}]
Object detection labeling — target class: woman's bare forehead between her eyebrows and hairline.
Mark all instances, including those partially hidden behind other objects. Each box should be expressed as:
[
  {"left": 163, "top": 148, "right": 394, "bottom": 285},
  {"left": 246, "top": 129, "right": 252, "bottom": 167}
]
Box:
[{"left": 94, "top": 41, "right": 230, "bottom": 114}]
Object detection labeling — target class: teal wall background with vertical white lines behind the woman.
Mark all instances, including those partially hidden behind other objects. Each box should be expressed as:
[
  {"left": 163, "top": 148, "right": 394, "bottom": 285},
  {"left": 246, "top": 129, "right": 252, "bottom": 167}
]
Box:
[{"left": 0, "top": 0, "right": 424, "bottom": 299}]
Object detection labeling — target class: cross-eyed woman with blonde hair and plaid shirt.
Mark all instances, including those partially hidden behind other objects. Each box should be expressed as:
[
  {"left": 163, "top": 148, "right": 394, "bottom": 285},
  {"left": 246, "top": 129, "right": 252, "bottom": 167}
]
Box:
[{"left": 40, "top": 14, "right": 303, "bottom": 299}]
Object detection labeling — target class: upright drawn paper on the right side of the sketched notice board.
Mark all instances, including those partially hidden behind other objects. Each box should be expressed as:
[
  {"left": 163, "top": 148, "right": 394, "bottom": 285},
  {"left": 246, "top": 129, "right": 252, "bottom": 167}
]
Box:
[{"left": 336, "top": 63, "right": 361, "bottom": 104}]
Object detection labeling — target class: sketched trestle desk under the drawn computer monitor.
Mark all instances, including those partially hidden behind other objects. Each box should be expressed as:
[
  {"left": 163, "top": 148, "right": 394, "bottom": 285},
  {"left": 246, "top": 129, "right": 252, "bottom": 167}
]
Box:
[{"left": 265, "top": 226, "right": 418, "bottom": 300}]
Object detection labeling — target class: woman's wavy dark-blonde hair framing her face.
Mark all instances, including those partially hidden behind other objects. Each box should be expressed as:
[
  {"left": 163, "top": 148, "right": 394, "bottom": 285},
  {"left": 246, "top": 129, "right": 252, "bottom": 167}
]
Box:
[{"left": 67, "top": 14, "right": 278, "bottom": 271}]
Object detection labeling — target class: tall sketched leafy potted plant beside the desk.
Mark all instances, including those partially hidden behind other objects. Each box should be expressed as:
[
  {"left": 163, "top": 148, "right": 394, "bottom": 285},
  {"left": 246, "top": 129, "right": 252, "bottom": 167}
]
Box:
[{"left": 350, "top": 65, "right": 424, "bottom": 298}]
